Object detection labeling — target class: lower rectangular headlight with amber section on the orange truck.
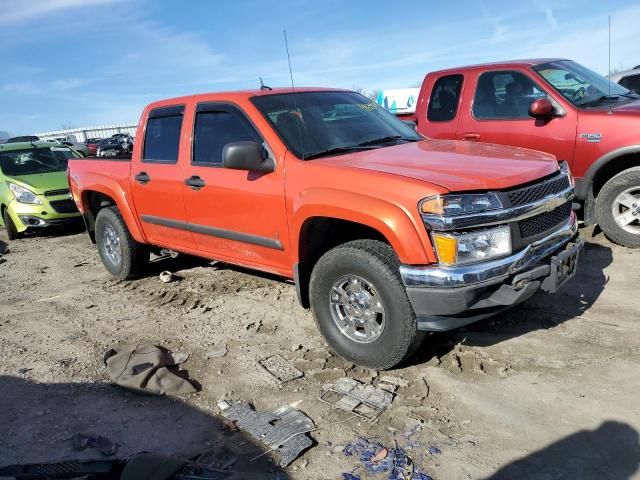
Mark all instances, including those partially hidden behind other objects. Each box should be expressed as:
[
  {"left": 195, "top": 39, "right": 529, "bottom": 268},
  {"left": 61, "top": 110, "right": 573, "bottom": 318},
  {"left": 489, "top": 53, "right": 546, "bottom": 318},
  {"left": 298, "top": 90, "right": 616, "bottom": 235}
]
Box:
[{"left": 432, "top": 226, "right": 511, "bottom": 265}]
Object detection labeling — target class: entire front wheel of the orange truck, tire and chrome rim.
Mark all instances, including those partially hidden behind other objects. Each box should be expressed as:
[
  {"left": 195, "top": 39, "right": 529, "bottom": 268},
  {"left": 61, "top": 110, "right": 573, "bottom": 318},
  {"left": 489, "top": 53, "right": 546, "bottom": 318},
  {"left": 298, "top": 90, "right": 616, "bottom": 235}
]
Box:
[{"left": 309, "top": 240, "right": 423, "bottom": 369}]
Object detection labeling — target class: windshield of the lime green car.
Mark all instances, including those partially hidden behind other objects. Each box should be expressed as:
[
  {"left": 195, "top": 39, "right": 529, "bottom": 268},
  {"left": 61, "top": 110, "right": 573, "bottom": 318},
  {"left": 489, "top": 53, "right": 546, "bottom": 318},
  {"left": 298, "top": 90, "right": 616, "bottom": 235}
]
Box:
[{"left": 0, "top": 147, "right": 79, "bottom": 177}]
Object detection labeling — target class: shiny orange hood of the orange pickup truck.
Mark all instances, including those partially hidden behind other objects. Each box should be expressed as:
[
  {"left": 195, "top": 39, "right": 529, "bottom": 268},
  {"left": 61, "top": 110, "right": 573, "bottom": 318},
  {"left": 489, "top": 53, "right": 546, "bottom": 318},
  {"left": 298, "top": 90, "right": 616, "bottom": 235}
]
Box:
[{"left": 310, "top": 140, "right": 558, "bottom": 192}]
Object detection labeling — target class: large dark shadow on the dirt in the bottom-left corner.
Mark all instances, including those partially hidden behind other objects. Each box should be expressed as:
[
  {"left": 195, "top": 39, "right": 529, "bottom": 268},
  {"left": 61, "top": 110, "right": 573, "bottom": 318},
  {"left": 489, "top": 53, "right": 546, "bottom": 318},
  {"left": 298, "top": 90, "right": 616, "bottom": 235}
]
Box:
[{"left": 0, "top": 376, "right": 288, "bottom": 479}]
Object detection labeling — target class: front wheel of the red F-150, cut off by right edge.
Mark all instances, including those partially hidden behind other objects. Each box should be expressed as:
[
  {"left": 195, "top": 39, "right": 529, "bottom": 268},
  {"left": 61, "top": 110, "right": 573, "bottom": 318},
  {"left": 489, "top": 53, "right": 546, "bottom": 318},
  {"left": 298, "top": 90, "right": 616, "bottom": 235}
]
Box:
[{"left": 596, "top": 167, "right": 640, "bottom": 248}]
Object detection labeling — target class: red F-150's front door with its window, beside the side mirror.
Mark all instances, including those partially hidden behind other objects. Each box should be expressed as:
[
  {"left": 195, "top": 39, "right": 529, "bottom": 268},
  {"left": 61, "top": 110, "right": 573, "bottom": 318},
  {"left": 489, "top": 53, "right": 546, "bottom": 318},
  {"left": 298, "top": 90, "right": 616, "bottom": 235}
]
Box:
[{"left": 457, "top": 69, "right": 577, "bottom": 164}]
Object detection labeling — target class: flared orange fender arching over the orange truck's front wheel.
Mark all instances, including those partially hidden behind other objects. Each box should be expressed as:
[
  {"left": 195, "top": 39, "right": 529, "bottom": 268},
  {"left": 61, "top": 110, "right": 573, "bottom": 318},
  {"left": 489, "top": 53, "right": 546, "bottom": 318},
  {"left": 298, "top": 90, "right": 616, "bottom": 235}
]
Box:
[{"left": 291, "top": 187, "right": 436, "bottom": 265}]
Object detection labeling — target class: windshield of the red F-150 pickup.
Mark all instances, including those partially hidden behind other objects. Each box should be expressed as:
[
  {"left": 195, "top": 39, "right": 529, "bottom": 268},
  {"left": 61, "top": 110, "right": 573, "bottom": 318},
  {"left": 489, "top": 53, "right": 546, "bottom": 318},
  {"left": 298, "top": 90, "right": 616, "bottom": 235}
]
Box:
[{"left": 533, "top": 60, "right": 633, "bottom": 107}]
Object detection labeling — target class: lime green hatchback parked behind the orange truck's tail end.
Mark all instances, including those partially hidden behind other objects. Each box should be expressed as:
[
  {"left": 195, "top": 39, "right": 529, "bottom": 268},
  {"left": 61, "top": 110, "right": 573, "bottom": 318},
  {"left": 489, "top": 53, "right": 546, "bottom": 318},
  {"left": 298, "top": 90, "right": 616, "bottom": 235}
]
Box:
[{"left": 0, "top": 142, "right": 80, "bottom": 240}]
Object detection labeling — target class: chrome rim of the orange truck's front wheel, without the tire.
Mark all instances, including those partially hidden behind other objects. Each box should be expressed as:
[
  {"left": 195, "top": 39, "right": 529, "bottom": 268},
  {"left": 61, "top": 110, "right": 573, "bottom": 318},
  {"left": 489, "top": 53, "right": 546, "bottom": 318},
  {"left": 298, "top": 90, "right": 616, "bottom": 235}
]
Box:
[{"left": 329, "top": 275, "right": 386, "bottom": 343}]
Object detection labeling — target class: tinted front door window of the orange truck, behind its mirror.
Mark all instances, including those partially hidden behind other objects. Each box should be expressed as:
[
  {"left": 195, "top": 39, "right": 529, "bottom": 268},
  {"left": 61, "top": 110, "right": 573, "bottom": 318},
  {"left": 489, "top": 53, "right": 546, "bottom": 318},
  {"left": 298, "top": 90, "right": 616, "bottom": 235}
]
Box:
[{"left": 191, "top": 106, "right": 262, "bottom": 166}]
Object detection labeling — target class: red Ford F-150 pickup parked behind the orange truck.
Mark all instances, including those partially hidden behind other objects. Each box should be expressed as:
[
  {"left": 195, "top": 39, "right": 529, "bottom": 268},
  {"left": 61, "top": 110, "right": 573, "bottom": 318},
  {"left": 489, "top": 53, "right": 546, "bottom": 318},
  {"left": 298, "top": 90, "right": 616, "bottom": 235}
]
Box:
[{"left": 408, "top": 59, "right": 640, "bottom": 247}]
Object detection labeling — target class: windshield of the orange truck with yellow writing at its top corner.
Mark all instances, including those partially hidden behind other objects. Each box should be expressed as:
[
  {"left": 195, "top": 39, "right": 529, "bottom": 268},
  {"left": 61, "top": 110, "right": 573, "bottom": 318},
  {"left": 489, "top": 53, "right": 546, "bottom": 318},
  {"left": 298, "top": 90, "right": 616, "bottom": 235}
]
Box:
[{"left": 251, "top": 92, "right": 422, "bottom": 159}]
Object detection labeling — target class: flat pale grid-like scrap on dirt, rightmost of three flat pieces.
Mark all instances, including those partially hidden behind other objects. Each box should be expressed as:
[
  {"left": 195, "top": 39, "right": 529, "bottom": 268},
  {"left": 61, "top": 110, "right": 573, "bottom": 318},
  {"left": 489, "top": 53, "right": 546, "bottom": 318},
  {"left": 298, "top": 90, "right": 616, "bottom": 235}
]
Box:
[{"left": 320, "top": 378, "right": 393, "bottom": 422}]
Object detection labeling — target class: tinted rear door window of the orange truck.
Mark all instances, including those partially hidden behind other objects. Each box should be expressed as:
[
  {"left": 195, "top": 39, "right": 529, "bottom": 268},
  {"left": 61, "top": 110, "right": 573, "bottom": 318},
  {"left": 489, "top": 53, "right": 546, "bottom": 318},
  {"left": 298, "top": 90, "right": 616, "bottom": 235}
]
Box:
[{"left": 142, "top": 106, "right": 184, "bottom": 163}]
